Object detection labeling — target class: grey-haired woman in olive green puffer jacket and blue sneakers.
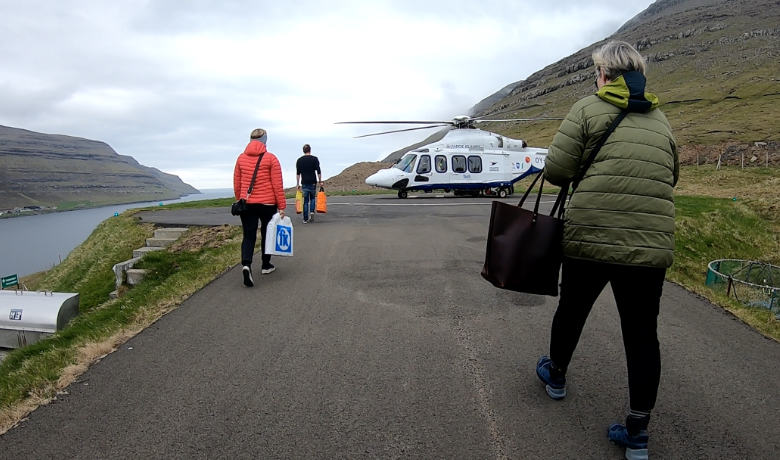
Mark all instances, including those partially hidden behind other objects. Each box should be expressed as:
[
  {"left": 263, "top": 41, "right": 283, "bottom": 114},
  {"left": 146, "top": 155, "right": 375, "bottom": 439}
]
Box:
[{"left": 537, "top": 41, "right": 679, "bottom": 458}]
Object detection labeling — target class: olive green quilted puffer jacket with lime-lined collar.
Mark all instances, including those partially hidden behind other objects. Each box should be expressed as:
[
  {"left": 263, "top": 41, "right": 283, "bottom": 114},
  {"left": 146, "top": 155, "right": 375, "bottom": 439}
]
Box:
[{"left": 544, "top": 72, "right": 679, "bottom": 268}]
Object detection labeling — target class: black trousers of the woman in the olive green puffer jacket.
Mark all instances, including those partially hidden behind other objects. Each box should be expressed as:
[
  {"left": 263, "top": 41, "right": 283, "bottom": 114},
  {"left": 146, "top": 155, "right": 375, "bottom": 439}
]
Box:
[{"left": 550, "top": 258, "right": 666, "bottom": 412}]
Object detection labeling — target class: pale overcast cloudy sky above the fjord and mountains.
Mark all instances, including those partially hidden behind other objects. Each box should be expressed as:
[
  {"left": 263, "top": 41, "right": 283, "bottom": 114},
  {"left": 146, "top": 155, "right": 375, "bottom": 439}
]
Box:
[{"left": 0, "top": 0, "right": 652, "bottom": 189}]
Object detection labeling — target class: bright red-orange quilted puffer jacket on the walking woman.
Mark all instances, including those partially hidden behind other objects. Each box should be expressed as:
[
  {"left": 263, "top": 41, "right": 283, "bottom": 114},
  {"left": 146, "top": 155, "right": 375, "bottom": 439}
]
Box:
[{"left": 238, "top": 140, "right": 287, "bottom": 209}]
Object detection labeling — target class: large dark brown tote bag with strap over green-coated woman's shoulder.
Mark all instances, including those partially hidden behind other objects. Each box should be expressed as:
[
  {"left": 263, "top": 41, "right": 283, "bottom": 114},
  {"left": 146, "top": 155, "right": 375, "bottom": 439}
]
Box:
[{"left": 482, "top": 111, "right": 627, "bottom": 296}]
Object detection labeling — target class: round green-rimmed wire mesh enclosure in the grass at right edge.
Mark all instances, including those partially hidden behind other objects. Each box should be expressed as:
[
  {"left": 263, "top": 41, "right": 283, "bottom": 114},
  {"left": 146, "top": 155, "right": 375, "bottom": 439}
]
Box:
[{"left": 705, "top": 259, "right": 780, "bottom": 319}]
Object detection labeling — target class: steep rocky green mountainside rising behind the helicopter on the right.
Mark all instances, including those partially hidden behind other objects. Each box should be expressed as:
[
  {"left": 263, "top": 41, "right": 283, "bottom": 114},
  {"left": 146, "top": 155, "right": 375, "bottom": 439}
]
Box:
[{"left": 473, "top": 0, "right": 780, "bottom": 165}]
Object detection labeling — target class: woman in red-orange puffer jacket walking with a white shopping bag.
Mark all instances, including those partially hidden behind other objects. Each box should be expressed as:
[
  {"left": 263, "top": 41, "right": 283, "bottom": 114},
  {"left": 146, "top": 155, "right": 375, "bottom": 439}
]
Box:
[{"left": 233, "top": 128, "right": 287, "bottom": 287}]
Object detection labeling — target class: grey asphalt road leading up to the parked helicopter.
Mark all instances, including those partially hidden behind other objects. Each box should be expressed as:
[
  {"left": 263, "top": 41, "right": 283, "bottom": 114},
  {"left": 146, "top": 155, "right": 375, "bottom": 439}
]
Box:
[{"left": 0, "top": 196, "right": 780, "bottom": 459}]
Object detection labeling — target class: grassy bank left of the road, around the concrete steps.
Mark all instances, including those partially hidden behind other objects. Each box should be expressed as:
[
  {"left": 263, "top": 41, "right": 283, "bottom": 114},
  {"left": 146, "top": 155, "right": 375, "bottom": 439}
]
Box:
[{"left": 0, "top": 214, "right": 241, "bottom": 433}]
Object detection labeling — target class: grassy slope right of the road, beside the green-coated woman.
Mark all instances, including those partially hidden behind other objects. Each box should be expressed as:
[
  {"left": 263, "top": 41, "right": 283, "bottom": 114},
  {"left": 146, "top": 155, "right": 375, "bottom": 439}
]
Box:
[{"left": 667, "top": 166, "right": 780, "bottom": 341}]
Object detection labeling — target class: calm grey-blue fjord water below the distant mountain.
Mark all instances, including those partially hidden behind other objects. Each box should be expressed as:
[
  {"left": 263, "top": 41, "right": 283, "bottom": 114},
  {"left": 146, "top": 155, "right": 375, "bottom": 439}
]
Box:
[{"left": 0, "top": 189, "right": 233, "bottom": 276}]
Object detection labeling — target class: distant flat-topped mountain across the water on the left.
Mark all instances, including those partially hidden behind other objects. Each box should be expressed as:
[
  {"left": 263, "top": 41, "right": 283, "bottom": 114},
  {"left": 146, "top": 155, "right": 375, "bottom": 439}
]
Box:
[{"left": 0, "top": 126, "right": 199, "bottom": 210}]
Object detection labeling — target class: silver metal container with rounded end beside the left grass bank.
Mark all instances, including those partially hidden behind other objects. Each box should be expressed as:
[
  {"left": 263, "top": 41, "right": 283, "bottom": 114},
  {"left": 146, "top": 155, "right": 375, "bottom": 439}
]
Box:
[{"left": 0, "top": 290, "right": 79, "bottom": 348}]
